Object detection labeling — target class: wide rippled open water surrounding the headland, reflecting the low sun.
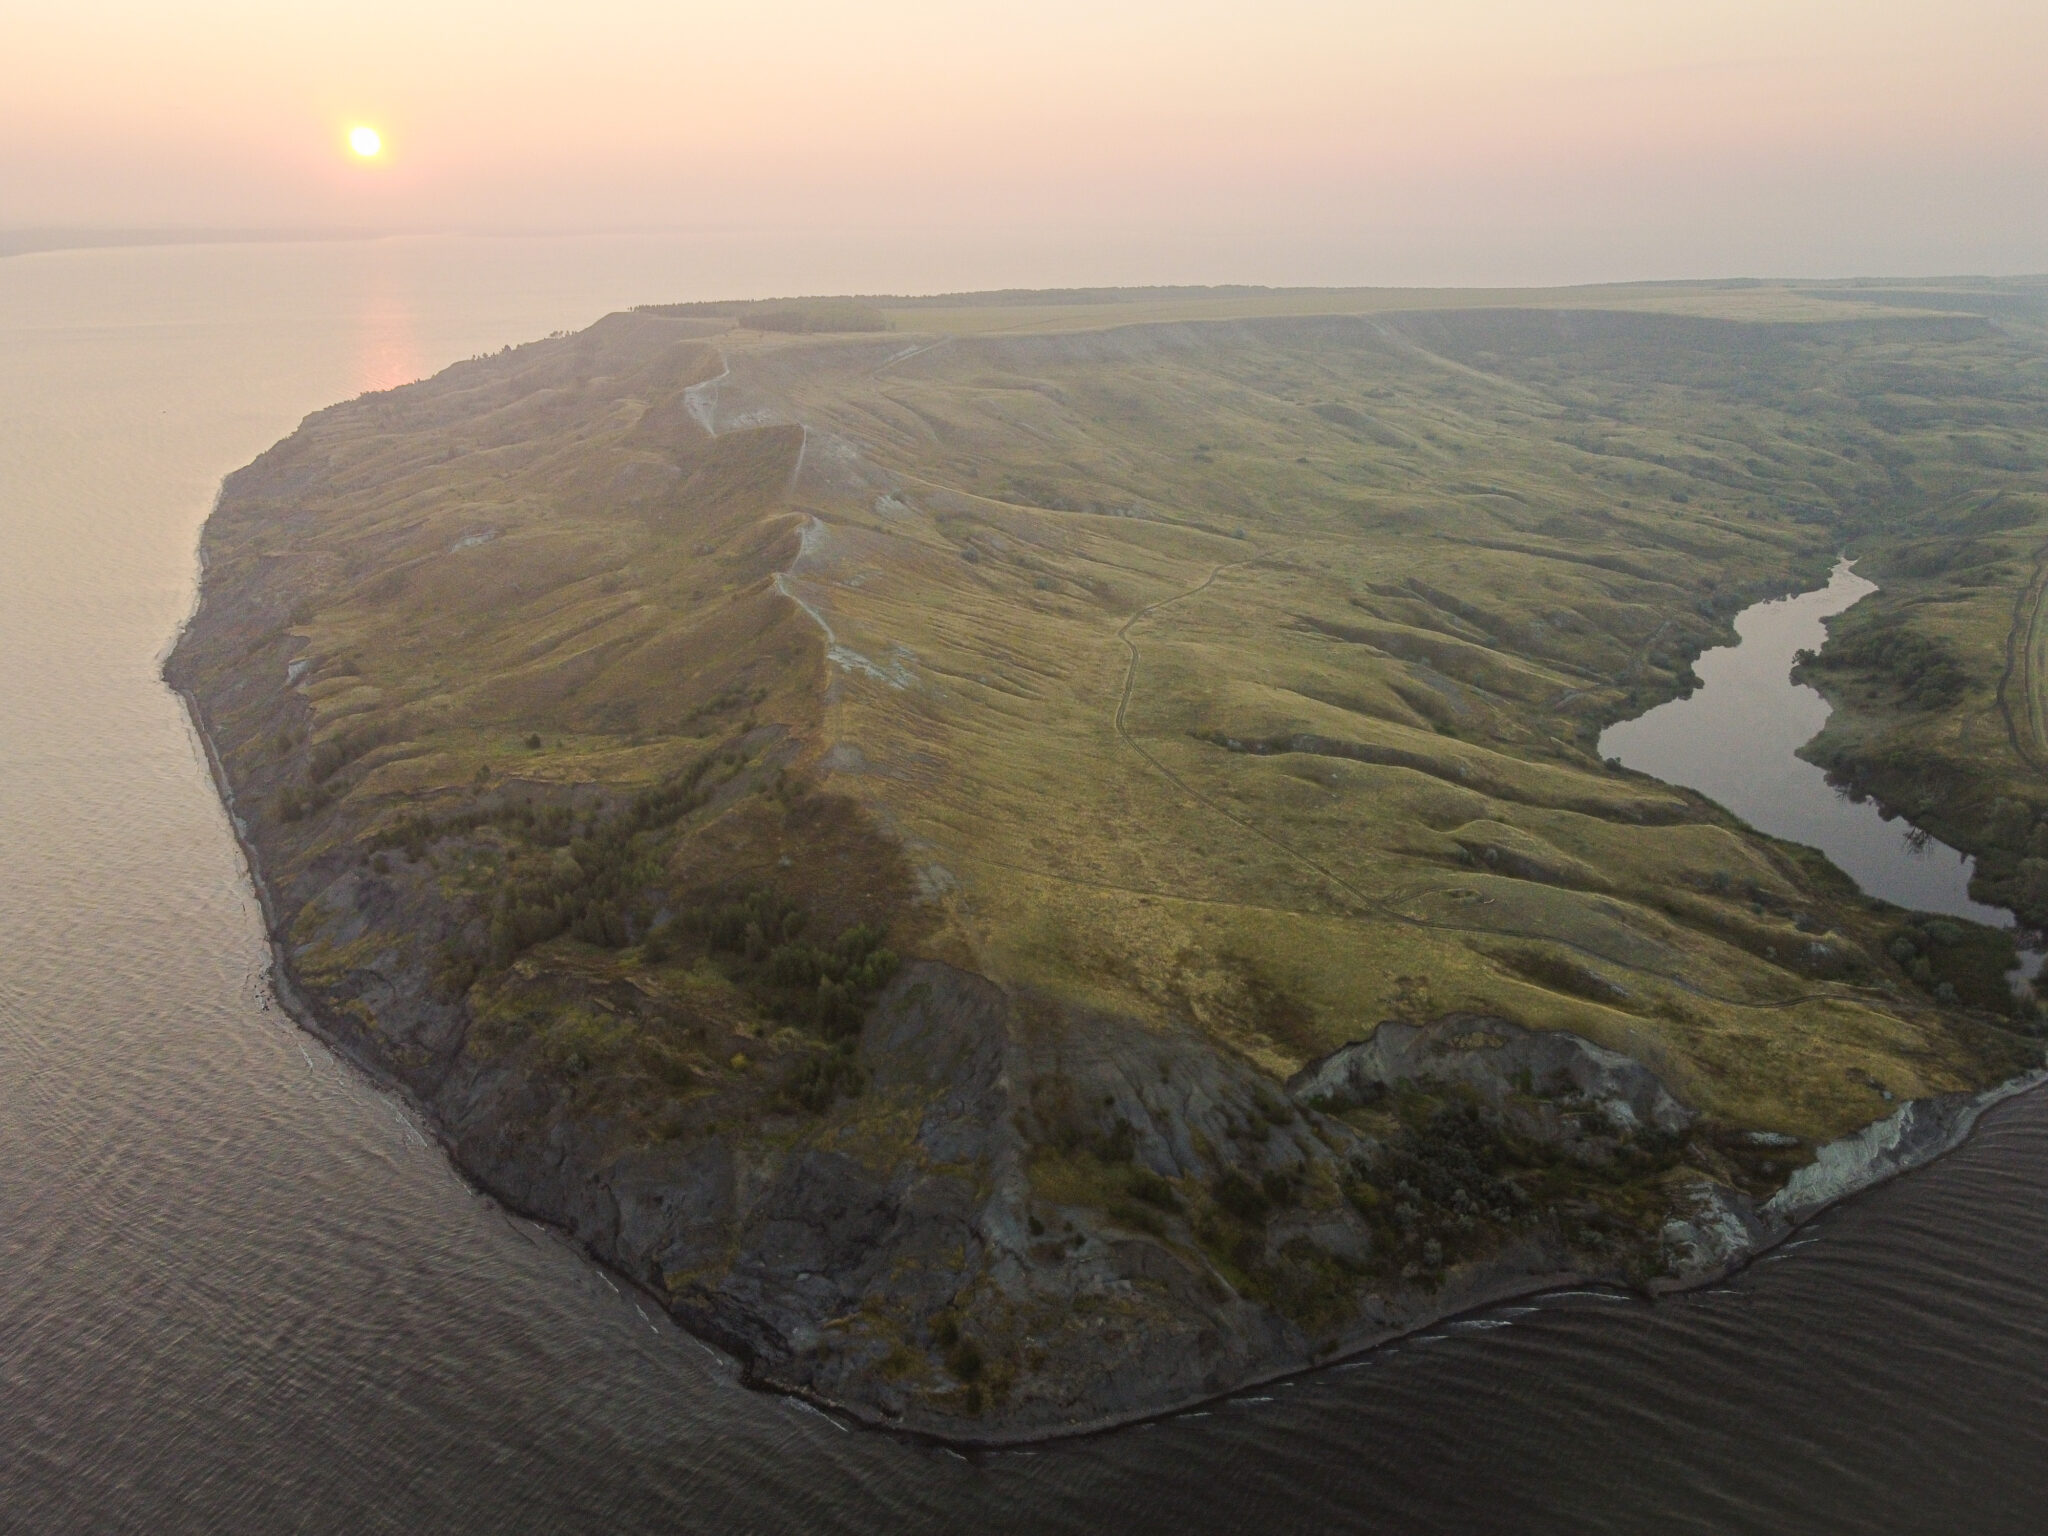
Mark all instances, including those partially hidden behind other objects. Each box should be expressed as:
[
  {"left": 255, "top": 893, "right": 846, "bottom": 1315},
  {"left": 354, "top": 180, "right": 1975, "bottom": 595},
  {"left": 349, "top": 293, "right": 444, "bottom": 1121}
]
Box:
[{"left": 0, "top": 242, "right": 2048, "bottom": 1536}]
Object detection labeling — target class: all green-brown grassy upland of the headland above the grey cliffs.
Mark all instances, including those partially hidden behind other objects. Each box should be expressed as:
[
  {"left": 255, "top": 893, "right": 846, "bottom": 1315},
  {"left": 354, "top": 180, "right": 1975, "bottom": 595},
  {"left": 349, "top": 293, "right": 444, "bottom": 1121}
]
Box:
[{"left": 180, "top": 285, "right": 2048, "bottom": 1187}]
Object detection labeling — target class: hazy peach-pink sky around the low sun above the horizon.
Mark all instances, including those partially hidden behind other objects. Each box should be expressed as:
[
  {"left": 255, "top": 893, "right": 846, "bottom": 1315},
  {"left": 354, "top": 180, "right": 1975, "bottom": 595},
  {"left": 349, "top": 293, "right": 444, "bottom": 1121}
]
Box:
[{"left": 0, "top": 0, "right": 2048, "bottom": 283}]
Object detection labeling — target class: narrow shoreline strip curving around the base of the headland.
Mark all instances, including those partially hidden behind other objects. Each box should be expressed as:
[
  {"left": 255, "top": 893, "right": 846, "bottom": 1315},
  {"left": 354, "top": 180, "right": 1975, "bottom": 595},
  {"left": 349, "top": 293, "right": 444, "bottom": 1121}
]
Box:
[{"left": 166, "top": 659, "right": 2048, "bottom": 1452}]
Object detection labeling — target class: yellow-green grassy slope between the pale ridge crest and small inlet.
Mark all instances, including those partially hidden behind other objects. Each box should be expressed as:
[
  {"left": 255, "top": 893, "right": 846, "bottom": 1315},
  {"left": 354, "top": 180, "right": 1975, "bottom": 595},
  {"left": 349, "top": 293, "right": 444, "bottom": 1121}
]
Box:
[{"left": 762, "top": 296, "right": 2030, "bottom": 1135}]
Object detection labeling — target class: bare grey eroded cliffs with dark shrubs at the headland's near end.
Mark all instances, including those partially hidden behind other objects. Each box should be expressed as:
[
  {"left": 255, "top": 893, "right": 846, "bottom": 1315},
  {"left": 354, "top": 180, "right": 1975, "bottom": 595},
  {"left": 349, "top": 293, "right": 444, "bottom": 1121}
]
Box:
[{"left": 172, "top": 765, "right": 2031, "bottom": 1442}]
